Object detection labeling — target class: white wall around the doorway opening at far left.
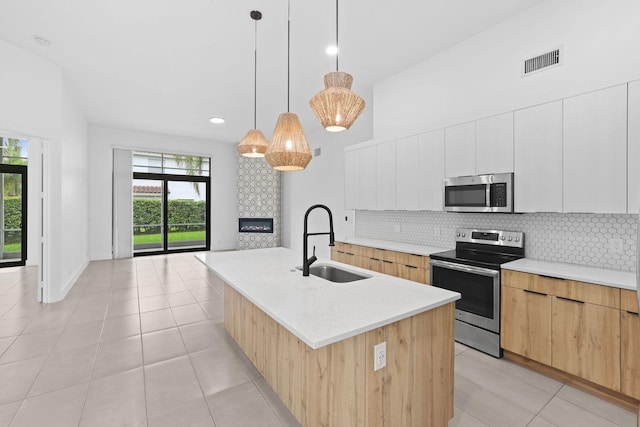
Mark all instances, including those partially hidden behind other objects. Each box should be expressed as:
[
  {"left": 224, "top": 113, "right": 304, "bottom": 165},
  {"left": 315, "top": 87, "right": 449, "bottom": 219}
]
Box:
[{"left": 0, "top": 41, "right": 88, "bottom": 302}]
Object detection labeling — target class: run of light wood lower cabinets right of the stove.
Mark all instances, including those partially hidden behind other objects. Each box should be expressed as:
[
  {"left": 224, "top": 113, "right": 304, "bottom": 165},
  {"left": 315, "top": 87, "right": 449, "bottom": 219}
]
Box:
[{"left": 501, "top": 270, "right": 640, "bottom": 399}]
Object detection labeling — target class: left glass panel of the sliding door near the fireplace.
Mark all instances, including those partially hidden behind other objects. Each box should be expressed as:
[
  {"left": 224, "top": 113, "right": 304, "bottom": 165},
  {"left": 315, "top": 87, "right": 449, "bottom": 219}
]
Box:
[{"left": 132, "top": 179, "right": 165, "bottom": 254}]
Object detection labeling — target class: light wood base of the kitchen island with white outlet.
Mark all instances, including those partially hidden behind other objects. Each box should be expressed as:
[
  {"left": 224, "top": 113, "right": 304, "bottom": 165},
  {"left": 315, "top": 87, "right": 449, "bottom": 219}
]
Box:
[{"left": 224, "top": 284, "right": 454, "bottom": 427}]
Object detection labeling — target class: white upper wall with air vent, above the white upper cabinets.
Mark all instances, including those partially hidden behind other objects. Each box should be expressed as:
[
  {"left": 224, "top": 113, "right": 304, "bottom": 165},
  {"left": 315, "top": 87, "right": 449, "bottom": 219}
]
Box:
[{"left": 373, "top": 0, "right": 640, "bottom": 138}]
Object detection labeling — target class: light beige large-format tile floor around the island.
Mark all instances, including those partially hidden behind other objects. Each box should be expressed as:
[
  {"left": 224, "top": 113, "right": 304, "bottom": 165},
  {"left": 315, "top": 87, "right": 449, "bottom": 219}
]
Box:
[{"left": 0, "top": 254, "right": 636, "bottom": 427}]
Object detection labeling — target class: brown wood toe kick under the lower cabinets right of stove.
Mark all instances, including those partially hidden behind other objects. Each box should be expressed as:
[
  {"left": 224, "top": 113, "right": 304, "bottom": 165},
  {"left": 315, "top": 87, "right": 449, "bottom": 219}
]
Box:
[{"left": 504, "top": 350, "right": 640, "bottom": 411}]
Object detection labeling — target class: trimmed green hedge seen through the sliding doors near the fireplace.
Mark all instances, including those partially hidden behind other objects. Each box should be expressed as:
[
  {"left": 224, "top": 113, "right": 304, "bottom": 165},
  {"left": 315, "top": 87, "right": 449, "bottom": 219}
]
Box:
[{"left": 133, "top": 198, "right": 207, "bottom": 235}]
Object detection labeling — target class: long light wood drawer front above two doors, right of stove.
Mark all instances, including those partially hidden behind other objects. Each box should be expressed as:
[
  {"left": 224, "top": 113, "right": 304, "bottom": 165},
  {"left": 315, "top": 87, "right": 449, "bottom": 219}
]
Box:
[{"left": 502, "top": 270, "right": 620, "bottom": 308}]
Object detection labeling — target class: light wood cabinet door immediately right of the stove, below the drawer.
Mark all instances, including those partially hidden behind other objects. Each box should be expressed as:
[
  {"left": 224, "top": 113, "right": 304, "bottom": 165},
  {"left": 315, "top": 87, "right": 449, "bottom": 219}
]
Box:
[{"left": 500, "top": 286, "right": 553, "bottom": 365}]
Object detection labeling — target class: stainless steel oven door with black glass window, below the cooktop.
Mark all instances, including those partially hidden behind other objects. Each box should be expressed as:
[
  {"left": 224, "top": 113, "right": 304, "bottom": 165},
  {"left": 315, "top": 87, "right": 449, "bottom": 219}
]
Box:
[{"left": 431, "top": 259, "right": 500, "bottom": 333}]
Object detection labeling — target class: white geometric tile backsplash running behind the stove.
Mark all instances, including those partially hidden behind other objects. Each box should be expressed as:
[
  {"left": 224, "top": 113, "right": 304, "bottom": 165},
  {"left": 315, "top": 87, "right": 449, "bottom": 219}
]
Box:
[{"left": 355, "top": 211, "right": 638, "bottom": 271}]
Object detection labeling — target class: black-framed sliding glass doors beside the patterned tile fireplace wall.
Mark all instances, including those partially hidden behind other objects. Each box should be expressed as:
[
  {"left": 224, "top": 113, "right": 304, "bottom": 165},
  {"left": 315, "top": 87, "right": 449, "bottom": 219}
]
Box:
[{"left": 132, "top": 172, "right": 211, "bottom": 256}]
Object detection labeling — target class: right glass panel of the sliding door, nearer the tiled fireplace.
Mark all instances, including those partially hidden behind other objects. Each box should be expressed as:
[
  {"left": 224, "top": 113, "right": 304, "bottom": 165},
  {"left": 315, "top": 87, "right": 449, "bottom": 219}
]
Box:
[{"left": 167, "top": 181, "right": 207, "bottom": 250}]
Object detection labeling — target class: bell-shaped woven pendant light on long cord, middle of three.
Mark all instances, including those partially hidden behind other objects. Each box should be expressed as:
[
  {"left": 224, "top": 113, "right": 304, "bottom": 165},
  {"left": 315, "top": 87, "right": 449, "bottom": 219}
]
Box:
[{"left": 264, "top": 1, "right": 313, "bottom": 172}]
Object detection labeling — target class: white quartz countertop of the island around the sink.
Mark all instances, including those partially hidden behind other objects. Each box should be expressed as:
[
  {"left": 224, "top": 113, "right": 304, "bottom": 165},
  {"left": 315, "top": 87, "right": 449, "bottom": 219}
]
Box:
[{"left": 196, "top": 248, "right": 460, "bottom": 349}]
